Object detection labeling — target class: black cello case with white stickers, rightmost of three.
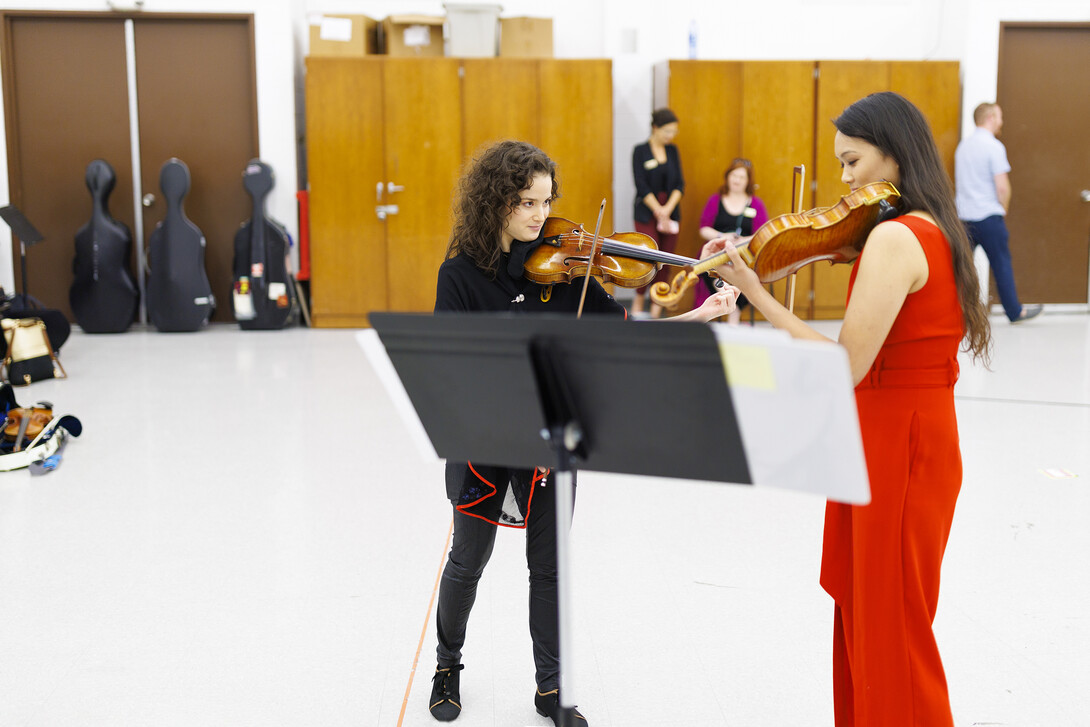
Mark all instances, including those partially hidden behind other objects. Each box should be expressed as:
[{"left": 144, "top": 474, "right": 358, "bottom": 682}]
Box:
[{"left": 231, "top": 159, "right": 296, "bottom": 330}]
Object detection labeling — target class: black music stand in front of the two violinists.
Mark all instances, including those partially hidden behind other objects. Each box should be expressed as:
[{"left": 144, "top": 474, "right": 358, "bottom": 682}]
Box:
[{"left": 371, "top": 313, "right": 752, "bottom": 724}]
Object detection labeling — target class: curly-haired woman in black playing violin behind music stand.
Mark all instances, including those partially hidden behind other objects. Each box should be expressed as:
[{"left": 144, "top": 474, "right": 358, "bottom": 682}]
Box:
[{"left": 428, "top": 141, "right": 737, "bottom": 725}]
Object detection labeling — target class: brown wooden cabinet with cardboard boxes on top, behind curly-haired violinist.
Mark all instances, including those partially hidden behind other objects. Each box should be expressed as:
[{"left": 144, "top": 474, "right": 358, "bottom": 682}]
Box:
[{"left": 306, "top": 58, "right": 613, "bottom": 327}]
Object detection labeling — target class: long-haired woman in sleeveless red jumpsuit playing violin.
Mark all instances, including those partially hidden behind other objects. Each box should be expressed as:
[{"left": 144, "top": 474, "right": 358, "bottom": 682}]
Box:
[{"left": 703, "top": 93, "right": 991, "bottom": 727}]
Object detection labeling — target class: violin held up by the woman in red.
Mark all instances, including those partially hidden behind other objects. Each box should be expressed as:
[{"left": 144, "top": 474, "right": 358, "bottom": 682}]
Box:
[{"left": 651, "top": 182, "right": 900, "bottom": 307}]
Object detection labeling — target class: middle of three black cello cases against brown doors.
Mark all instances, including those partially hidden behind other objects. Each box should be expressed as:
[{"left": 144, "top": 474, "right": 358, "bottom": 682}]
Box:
[{"left": 147, "top": 158, "right": 216, "bottom": 331}]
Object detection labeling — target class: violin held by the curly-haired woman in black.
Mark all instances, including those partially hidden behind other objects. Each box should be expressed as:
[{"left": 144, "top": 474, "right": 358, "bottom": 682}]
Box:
[{"left": 523, "top": 217, "right": 700, "bottom": 288}]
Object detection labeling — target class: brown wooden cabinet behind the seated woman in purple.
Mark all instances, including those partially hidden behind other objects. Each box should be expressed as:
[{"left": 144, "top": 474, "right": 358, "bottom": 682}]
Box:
[{"left": 655, "top": 56, "right": 961, "bottom": 318}]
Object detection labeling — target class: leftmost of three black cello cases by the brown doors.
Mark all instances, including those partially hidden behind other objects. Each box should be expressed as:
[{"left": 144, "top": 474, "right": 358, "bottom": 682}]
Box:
[{"left": 69, "top": 159, "right": 140, "bottom": 334}]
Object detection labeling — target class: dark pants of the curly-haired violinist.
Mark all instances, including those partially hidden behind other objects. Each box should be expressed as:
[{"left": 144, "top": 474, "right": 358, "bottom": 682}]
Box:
[{"left": 435, "top": 478, "right": 560, "bottom": 692}]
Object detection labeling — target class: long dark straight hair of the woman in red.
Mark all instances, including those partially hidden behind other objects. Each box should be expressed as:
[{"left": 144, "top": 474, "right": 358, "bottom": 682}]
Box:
[{"left": 833, "top": 92, "right": 992, "bottom": 364}]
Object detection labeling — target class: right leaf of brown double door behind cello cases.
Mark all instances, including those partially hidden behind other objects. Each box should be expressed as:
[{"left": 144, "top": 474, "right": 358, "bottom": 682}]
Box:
[{"left": 135, "top": 17, "right": 257, "bottom": 322}]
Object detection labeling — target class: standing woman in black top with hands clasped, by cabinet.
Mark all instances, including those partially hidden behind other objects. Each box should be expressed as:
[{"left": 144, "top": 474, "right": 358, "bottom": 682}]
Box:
[{"left": 632, "top": 109, "right": 685, "bottom": 318}]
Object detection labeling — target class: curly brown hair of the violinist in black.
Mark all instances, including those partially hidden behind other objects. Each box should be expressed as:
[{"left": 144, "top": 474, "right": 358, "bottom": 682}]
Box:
[{"left": 447, "top": 140, "right": 560, "bottom": 278}]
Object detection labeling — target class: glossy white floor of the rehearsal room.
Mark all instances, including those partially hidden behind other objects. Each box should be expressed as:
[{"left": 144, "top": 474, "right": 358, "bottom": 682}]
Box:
[{"left": 0, "top": 314, "right": 1090, "bottom": 727}]
